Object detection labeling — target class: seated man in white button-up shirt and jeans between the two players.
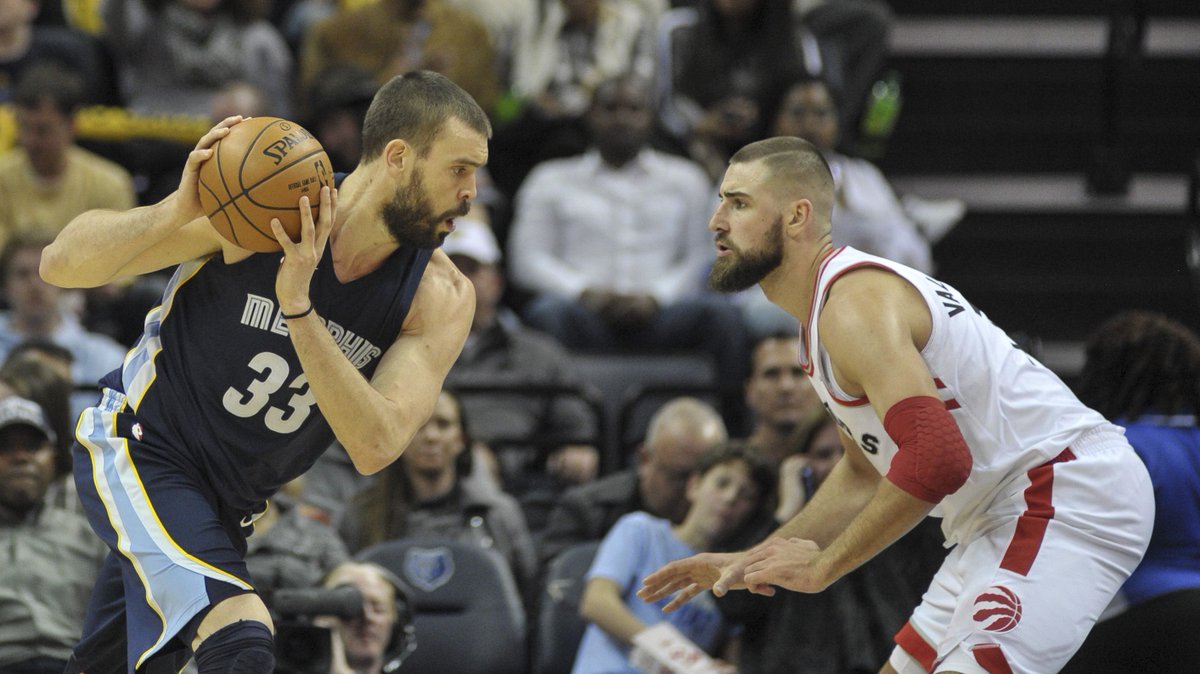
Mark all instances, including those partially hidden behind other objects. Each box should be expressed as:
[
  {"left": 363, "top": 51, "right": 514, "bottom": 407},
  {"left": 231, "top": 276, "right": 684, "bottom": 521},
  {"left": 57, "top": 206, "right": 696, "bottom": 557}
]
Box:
[{"left": 509, "top": 76, "right": 746, "bottom": 426}]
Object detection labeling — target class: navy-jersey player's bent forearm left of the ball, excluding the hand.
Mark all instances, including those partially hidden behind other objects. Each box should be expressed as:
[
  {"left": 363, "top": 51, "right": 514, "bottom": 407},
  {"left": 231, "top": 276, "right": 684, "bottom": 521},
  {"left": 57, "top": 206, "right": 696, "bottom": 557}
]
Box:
[{"left": 40, "top": 193, "right": 191, "bottom": 288}]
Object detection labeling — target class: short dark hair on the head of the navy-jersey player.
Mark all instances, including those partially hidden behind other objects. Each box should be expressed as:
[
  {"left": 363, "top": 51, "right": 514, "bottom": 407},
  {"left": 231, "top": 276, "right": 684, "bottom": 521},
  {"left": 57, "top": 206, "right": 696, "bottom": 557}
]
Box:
[{"left": 362, "top": 71, "right": 492, "bottom": 161}]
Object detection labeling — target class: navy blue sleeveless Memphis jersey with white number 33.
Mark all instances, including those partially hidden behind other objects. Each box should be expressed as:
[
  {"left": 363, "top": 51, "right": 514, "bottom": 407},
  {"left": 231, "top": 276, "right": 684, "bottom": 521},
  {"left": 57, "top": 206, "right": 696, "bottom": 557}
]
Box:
[{"left": 102, "top": 218, "right": 432, "bottom": 512}]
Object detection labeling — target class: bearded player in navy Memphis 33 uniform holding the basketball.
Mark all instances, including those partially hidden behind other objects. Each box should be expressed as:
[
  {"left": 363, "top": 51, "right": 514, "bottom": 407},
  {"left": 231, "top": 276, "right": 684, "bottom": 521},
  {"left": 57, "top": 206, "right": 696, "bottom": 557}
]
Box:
[{"left": 41, "top": 72, "right": 491, "bottom": 674}]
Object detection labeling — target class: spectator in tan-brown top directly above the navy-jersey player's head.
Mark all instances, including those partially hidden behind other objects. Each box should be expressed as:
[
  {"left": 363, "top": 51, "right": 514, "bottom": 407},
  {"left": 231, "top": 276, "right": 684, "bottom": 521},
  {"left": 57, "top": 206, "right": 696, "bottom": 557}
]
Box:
[{"left": 300, "top": 0, "right": 499, "bottom": 113}]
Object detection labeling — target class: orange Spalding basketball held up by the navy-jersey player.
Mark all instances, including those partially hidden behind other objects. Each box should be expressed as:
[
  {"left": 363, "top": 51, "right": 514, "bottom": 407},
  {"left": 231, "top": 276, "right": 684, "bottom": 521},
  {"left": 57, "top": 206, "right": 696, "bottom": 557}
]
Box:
[{"left": 199, "top": 118, "right": 334, "bottom": 252}]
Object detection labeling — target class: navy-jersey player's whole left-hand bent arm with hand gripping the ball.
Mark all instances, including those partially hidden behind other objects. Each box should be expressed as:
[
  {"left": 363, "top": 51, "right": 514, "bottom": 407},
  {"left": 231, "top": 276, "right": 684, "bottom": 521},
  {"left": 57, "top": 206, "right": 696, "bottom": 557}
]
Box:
[{"left": 41, "top": 116, "right": 241, "bottom": 288}]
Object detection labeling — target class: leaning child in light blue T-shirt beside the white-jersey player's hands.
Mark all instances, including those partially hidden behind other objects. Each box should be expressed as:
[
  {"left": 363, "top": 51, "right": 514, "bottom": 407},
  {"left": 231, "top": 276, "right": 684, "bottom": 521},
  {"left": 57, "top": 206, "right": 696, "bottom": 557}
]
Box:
[{"left": 572, "top": 443, "right": 775, "bottom": 674}]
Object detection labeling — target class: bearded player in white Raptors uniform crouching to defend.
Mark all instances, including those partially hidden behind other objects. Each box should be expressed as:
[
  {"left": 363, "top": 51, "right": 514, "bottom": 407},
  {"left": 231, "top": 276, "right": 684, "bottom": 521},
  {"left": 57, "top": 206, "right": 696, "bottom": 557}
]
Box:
[{"left": 640, "top": 138, "right": 1154, "bottom": 674}]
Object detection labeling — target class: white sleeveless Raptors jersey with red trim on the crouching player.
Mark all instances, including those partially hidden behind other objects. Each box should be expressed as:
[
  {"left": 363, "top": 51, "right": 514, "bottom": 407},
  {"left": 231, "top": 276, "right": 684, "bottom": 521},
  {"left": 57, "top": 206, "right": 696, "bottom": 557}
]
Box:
[{"left": 799, "top": 247, "right": 1109, "bottom": 544}]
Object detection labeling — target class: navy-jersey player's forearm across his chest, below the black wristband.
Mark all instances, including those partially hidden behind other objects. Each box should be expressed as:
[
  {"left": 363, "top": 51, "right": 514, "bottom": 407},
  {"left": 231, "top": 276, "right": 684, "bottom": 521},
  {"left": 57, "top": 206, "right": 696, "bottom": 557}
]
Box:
[{"left": 288, "top": 309, "right": 436, "bottom": 475}]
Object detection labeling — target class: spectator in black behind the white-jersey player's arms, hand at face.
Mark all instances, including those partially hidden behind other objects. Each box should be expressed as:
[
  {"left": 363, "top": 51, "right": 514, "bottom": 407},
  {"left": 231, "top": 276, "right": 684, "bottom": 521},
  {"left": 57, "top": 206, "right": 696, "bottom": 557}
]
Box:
[{"left": 716, "top": 408, "right": 946, "bottom": 674}]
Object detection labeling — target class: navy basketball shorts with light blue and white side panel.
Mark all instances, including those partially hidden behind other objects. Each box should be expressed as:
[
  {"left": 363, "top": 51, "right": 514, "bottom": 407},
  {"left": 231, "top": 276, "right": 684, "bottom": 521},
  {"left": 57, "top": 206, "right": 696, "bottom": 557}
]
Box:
[{"left": 74, "top": 390, "right": 254, "bottom": 674}]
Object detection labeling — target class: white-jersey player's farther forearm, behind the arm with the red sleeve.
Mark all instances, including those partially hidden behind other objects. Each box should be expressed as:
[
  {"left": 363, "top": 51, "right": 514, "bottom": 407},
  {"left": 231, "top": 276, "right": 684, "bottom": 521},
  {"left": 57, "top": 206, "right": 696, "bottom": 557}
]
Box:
[{"left": 769, "top": 450, "right": 880, "bottom": 548}]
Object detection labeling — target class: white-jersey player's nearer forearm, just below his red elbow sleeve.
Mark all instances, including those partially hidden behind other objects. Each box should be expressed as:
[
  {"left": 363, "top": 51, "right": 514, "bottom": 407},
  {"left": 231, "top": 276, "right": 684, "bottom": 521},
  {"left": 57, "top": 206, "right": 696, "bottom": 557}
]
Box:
[{"left": 818, "top": 480, "right": 936, "bottom": 582}]
